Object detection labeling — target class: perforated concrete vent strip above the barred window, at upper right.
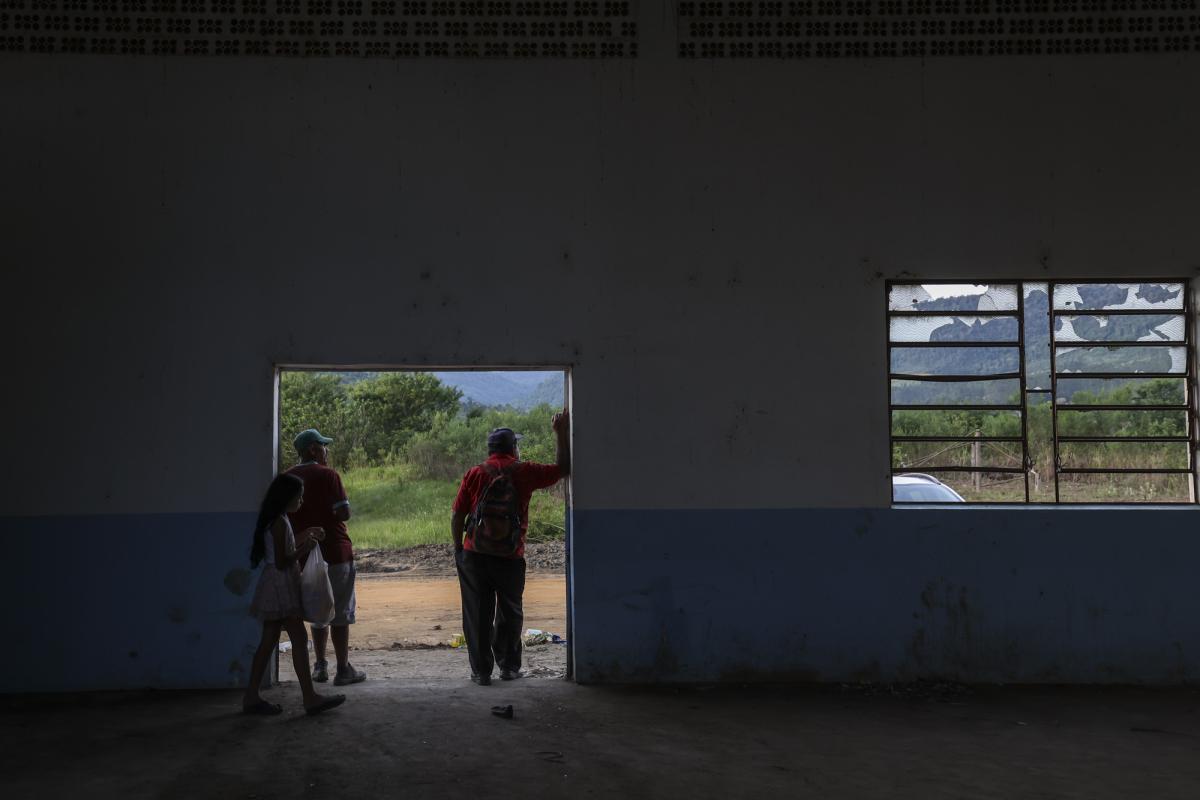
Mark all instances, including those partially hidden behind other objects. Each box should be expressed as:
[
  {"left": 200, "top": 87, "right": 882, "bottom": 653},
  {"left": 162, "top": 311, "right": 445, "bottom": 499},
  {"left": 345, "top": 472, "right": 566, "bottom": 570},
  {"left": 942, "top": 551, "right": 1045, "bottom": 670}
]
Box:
[{"left": 678, "top": 0, "right": 1200, "bottom": 59}]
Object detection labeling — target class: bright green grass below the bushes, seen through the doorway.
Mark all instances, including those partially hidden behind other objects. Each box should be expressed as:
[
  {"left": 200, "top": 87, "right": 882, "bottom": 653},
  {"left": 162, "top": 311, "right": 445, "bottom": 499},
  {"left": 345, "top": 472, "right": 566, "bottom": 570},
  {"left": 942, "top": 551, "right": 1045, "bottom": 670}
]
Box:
[{"left": 342, "top": 464, "right": 565, "bottom": 549}]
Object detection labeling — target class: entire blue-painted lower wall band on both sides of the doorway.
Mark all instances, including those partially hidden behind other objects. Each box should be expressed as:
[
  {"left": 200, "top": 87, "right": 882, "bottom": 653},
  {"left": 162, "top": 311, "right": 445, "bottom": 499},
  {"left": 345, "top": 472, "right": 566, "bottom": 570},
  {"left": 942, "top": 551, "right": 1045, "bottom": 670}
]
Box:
[{"left": 0, "top": 509, "right": 1200, "bottom": 692}]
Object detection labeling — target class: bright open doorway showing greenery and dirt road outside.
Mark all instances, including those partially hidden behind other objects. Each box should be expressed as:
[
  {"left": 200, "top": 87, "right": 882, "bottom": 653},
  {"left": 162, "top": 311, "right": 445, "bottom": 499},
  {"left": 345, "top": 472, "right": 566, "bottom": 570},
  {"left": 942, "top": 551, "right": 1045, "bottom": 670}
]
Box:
[{"left": 275, "top": 366, "right": 572, "bottom": 681}]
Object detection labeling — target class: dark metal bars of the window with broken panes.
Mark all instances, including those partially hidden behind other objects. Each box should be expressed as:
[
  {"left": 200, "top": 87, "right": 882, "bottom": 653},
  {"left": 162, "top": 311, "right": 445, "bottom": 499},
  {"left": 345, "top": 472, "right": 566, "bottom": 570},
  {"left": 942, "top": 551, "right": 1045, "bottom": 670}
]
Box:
[{"left": 884, "top": 277, "right": 1200, "bottom": 505}]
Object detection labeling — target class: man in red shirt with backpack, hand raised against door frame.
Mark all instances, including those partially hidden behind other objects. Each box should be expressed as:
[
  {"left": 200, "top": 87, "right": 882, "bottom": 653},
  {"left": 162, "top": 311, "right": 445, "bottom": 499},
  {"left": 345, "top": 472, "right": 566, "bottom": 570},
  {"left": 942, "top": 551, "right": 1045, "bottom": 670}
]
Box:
[{"left": 450, "top": 410, "right": 571, "bottom": 686}]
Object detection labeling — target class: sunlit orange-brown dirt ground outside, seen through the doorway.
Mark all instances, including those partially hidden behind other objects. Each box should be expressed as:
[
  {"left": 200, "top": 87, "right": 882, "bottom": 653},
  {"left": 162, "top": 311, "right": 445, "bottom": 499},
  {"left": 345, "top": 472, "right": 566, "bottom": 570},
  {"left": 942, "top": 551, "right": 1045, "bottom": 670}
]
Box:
[{"left": 278, "top": 570, "right": 566, "bottom": 681}]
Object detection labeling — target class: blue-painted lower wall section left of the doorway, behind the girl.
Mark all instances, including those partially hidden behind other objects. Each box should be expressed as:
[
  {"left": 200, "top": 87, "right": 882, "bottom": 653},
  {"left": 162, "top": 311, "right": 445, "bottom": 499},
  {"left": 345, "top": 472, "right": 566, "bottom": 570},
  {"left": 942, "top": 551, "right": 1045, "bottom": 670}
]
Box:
[{"left": 0, "top": 513, "right": 260, "bottom": 692}]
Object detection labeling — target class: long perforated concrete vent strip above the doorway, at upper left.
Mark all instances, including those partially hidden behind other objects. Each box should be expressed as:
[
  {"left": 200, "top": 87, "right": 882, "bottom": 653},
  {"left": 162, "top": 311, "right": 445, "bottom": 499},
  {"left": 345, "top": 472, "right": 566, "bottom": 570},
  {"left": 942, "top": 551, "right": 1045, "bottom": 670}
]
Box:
[{"left": 0, "top": 0, "right": 637, "bottom": 59}]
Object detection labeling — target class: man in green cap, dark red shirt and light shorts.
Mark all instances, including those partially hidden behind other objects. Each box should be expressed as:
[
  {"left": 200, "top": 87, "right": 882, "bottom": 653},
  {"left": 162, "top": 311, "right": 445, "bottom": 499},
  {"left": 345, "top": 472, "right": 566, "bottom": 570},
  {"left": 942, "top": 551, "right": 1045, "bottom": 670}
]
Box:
[{"left": 288, "top": 428, "right": 367, "bottom": 686}]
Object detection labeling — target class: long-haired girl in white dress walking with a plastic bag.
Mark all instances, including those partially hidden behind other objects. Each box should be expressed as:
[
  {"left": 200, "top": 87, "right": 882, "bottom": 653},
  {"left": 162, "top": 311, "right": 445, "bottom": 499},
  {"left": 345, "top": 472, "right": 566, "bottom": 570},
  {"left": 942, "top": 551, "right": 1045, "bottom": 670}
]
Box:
[{"left": 241, "top": 474, "right": 346, "bottom": 715}]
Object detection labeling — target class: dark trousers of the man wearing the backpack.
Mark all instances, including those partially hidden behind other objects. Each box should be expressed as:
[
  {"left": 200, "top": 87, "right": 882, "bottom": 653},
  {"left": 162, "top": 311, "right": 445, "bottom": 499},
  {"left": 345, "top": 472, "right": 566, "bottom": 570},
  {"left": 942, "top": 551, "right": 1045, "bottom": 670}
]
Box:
[{"left": 455, "top": 551, "right": 526, "bottom": 675}]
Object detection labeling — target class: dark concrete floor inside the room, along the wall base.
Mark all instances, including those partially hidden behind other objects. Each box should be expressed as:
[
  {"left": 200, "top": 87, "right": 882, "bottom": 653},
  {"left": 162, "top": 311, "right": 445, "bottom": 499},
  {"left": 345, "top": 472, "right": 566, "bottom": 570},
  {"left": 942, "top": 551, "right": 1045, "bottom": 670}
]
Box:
[{"left": 0, "top": 678, "right": 1200, "bottom": 800}]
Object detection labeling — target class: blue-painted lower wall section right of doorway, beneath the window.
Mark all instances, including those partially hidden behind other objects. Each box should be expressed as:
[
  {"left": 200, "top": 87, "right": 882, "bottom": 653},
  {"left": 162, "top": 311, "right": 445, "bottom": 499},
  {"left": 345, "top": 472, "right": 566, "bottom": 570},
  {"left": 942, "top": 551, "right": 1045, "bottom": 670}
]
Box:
[{"left": 571, "top": 507, "right": 1200, "bottom": 684}]
